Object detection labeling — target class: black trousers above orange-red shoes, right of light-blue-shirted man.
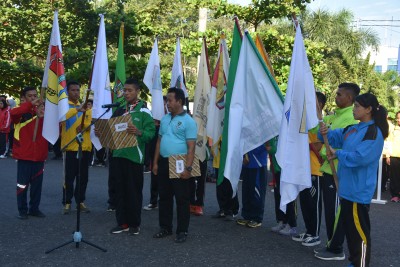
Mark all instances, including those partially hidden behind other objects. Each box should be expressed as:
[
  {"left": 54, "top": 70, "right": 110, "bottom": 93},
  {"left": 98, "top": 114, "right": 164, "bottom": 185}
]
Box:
[{"left": 190, "top": 160, "right": 207, "bottom": 206}]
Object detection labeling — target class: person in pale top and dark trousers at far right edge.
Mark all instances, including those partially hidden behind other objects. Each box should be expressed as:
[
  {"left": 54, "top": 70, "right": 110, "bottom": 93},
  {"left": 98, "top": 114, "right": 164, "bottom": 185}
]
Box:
[{"left": 386, "top": 111, "right": 400, "bottom": 202}]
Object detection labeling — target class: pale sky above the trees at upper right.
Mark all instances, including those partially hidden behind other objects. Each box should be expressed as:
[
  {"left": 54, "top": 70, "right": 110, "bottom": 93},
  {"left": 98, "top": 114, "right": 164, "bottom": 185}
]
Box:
[{"left": 228, "top": 0, "right": 400, "bottom": 47}]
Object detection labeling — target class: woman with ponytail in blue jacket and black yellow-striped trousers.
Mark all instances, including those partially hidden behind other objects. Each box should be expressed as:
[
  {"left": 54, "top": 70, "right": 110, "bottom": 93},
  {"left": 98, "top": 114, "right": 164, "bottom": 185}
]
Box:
[{"left": 318, "top": 93, "right": 389, "bottom": 266}]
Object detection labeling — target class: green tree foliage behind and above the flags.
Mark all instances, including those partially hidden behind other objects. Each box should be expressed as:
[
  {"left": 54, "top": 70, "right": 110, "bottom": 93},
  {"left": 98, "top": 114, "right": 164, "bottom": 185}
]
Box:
[{"left": 0, "top": 0, "right": 400, "bottom": 116}]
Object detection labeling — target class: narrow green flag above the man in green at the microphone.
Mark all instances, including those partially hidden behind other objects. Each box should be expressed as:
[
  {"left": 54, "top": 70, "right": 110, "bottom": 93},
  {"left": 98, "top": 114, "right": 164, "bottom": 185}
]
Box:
[{"left": 113, "top": 22, "right": 126, "bottom": 105}]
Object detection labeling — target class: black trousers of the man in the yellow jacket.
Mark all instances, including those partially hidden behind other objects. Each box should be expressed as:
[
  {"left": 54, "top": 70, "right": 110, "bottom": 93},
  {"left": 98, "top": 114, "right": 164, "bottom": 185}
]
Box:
[{"left": 62, "top": 151, "right": 90, "bottom": 205}]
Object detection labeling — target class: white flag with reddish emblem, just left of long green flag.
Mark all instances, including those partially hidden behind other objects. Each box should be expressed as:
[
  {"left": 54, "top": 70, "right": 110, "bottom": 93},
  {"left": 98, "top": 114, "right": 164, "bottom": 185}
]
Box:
[{"left": 207, "top": 35, "right": 229, "bottom": 155}]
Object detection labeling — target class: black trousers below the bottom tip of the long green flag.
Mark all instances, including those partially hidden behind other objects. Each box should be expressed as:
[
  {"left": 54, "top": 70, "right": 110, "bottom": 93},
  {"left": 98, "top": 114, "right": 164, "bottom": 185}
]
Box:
[{"left": 215, "top": 169, "right": 239, "bottom": 215}]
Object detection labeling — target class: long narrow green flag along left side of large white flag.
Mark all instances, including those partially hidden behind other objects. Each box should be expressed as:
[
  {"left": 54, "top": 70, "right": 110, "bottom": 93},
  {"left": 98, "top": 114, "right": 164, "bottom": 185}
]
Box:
[{"left": 217, "top": 17, "right": 242, "bottom": 185}]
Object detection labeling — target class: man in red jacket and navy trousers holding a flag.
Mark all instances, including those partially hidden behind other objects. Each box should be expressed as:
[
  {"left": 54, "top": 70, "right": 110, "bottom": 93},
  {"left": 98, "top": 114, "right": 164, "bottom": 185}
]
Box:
[{"left": 10, "top": 87, "right": 48, "bottom": 220}]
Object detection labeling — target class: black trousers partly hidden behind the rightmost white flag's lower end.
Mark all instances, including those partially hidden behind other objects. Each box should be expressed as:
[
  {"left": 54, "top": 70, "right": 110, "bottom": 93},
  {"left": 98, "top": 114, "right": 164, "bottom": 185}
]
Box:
[{"left": 274, "top": 172, "right": 297, "bottom": 227}]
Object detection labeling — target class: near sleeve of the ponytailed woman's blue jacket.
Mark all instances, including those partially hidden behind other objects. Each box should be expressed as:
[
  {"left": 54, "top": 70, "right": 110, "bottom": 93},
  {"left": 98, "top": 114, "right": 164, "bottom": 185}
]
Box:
[{"left": 336, "top": 134, "right": 383, "bottom": 168}]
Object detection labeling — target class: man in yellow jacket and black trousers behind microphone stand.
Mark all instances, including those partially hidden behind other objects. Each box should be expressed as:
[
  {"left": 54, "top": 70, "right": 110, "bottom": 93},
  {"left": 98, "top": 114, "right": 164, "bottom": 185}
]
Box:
[{"left": 61, "top": 81, "right": 92, "bottom": 214}]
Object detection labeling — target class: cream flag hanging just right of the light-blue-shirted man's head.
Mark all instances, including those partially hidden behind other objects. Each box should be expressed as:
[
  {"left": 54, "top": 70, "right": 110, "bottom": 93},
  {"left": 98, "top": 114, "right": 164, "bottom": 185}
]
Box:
[{"left": 193, "top": 38, "right": 211, "bottom": 161}]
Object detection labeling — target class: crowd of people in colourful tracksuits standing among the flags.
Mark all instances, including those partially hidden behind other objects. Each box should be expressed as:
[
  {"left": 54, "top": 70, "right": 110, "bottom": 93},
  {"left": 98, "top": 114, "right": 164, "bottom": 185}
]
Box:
[{"left": 0, "top": 79, "right": 400, "bottom": 266}]
